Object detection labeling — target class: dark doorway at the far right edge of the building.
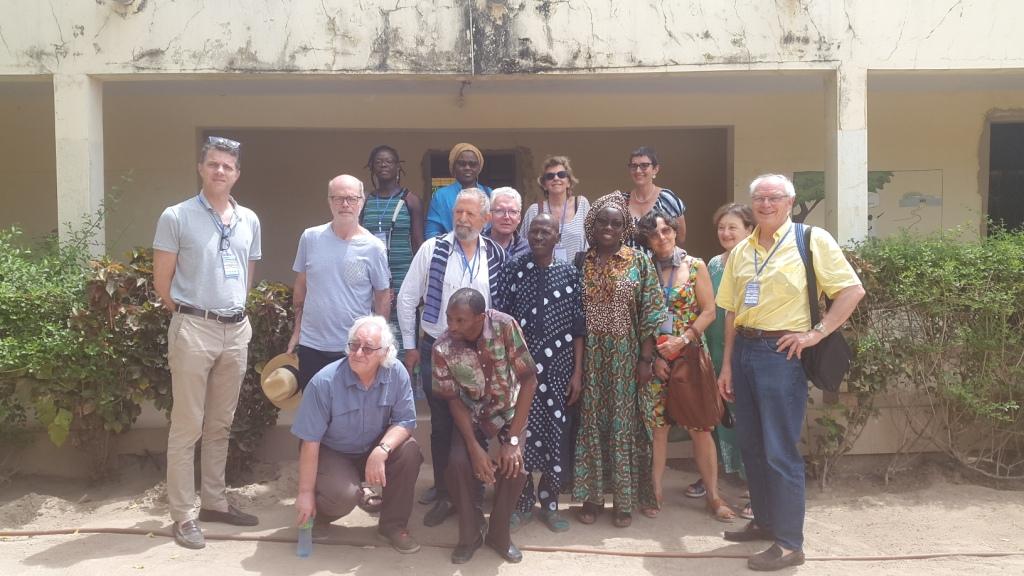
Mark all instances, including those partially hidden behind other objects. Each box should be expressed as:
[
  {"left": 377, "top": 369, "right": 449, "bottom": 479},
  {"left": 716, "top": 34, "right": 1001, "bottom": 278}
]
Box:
[{"left": 988, "top": 123, "right": 1024, "bottom": 230}]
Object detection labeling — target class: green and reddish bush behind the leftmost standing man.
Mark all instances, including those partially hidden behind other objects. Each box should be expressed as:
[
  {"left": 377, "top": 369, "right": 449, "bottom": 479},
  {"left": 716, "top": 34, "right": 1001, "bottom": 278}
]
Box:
[{"left": 0, "top": 230, "right": 292, "bottom": 479}]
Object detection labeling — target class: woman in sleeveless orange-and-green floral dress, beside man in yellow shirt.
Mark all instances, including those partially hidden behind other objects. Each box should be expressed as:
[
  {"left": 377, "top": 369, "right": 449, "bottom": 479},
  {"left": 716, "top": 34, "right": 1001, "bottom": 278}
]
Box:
[{"left": 638, "top": 209, "right": 736, "bottom": 522}]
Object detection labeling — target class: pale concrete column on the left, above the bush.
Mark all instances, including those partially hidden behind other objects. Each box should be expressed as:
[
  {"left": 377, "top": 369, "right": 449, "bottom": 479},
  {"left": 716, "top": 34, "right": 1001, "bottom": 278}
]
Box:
[{"left": 53, "top": 74, "right": 106, "bottom": 254}]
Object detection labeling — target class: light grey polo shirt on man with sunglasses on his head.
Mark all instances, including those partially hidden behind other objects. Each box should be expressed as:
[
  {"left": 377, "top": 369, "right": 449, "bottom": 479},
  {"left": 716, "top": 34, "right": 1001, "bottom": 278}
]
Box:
[{"left": 153, "top": 194, "right": 262, "bottom": 316}]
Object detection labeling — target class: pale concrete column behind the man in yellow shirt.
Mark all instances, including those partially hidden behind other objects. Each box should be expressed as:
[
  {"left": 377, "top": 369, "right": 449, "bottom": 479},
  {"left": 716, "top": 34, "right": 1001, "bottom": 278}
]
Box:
[{"left": 825, "top": 66, "right": 867, "bottom": 244}]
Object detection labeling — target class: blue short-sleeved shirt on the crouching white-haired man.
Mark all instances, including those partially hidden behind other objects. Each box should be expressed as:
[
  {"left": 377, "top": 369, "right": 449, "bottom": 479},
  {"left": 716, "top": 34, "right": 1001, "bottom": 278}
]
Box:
[{"left": 292, "top": 359, "right": 416, "bottom": 454}]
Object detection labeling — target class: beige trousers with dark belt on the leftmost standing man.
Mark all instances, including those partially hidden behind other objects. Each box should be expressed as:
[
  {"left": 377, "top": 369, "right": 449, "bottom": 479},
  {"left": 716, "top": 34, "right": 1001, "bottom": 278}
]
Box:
[{"left": 167, "top": 314, "right": 252, "bottom": 522}]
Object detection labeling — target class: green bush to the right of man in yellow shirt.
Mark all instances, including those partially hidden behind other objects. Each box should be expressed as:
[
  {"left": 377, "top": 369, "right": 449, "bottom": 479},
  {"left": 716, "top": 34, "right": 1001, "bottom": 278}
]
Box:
[{"left": 815, "top": 226, "right": 1024, "bottom": 479}]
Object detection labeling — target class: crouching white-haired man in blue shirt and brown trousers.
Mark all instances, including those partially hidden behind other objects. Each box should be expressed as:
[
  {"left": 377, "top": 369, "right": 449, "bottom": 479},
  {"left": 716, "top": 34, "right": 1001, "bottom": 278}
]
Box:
[{"left": 292, "top": 316, "right": 423, "bottom": 553}]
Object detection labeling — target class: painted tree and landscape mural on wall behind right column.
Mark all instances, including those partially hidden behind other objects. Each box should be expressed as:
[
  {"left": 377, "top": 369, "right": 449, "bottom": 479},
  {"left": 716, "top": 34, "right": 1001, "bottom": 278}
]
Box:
[{"left": 793, "top": 170, "right": 942, "bottom": 238}]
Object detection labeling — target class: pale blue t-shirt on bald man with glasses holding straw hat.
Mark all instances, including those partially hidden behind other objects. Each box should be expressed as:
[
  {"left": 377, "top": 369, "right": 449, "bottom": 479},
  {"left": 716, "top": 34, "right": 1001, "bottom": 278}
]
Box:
[{"left": 292, "top": 222, "right": 391, "bottom": 352}]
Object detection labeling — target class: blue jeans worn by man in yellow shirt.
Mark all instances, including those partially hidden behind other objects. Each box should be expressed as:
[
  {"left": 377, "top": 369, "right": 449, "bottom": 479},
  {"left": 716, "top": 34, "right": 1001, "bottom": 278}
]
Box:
[{"left": 732, "top": 334, "right": 807, "bottom": 550}]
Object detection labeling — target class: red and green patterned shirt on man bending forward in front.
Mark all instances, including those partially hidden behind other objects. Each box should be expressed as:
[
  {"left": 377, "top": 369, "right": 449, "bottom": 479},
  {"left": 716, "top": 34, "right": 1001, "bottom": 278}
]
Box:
[{"left": 433, "top": 310, "right": 537, "bottom": 437}]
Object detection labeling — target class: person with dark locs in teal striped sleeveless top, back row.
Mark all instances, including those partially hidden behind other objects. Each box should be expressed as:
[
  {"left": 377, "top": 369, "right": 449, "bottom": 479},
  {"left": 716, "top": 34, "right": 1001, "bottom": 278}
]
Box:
[{"left": 359, "top": 145, "right": 424, "bottom": 358}]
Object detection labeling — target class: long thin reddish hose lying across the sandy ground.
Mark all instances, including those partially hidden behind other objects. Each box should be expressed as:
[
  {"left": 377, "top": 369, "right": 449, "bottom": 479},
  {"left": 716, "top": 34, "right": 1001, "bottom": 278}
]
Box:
[{"left": 0, "top": 528, "right": 1024, "bottom": 562}]
